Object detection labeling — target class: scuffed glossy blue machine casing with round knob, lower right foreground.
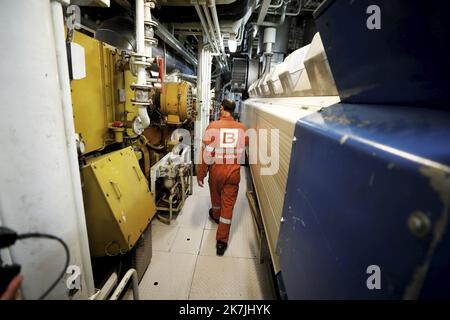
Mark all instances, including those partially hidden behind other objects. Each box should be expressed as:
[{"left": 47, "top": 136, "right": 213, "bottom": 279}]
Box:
[{"left": 278, "top": 104, "right": 450, "bottom": 299}]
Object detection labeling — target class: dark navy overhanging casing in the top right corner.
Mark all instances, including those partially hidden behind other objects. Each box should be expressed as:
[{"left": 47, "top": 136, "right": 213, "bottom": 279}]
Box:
[{"left": 315, "top": 0, "right": 450, "bottom": 110}]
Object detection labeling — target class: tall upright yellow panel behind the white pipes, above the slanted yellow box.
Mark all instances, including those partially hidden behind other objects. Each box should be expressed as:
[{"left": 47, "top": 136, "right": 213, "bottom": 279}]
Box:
[{"left": 71, "top": 32, "right": 117, "bottom": 153}]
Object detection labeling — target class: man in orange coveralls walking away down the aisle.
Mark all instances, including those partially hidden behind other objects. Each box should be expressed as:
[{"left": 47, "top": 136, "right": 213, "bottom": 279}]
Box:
[{"left": 197, "top": 99, "right": 248, "bottom": 256}]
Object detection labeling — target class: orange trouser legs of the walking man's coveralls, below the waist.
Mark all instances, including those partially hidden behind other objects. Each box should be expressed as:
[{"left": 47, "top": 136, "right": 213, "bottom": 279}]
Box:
[{"left": 208, "top": 164, "right": 241, "bottom": 242}]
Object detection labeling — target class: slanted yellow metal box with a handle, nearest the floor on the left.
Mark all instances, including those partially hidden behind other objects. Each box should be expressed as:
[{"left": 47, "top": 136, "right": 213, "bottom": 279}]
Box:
[{"left": 82, "top": 147, "right": 156, "bottom": 257}]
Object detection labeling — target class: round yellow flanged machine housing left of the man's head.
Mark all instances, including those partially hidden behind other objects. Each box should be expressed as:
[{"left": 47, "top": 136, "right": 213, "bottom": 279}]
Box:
[{"left": 160, "top": 81, "right": 194, "bottom": 125}]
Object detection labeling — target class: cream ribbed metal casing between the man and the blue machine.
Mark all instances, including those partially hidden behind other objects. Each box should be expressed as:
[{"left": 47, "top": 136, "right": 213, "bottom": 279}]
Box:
[{"left": 242, "top": 97, "right": 339, "bottom": 272}]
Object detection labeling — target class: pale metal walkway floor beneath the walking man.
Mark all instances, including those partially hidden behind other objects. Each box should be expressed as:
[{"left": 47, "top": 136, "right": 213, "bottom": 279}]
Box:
[{"left": 125, "top": 168, "right": 276, "bottom": 300}]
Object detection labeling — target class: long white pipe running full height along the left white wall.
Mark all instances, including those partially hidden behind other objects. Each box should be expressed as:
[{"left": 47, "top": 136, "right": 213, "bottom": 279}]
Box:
[{"left": 51, "top": 0, "right": 95, "bottom": 296}]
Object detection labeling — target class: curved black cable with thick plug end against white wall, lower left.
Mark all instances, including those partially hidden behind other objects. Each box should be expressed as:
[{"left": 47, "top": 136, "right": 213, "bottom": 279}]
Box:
[{"left": 0, "top": 227, "right": 70, "bottom": 300}]
